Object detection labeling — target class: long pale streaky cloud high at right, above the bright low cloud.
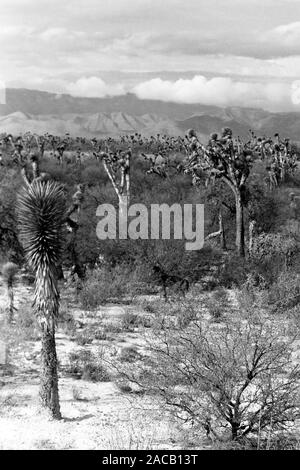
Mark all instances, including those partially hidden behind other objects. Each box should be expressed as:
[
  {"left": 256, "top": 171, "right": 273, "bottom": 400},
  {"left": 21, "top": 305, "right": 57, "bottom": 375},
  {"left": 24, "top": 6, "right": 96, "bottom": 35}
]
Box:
[{"left": 99, "top": 22, "right": 300, "bottom": 60}]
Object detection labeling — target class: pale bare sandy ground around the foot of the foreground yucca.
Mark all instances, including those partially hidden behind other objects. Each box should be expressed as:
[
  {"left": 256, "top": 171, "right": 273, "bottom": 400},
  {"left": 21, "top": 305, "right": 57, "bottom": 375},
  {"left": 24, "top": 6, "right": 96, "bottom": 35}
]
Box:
[{"left": 0, "top": 279, "right": 202, "bottom": 449}]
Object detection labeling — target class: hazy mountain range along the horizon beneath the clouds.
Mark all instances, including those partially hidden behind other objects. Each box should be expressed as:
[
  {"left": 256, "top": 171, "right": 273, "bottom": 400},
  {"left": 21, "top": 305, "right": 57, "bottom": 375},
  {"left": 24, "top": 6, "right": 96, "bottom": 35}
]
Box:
[{"left": 0, "top": 88, "right": 300, "bottom": 141}]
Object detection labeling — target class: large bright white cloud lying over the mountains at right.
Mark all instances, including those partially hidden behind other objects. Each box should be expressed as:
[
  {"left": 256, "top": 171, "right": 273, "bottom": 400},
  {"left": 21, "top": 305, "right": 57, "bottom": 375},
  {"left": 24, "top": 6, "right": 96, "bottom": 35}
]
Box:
[{"left": 133, "top": 75, "right": 300, "bottom": 109}]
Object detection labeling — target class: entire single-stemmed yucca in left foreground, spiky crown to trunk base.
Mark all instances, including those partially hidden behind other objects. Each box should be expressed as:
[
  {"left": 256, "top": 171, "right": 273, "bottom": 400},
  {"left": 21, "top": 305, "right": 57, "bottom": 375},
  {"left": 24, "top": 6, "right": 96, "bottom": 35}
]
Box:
[{"left": 17, "top": 181, "right": 66, "bottom": 419}]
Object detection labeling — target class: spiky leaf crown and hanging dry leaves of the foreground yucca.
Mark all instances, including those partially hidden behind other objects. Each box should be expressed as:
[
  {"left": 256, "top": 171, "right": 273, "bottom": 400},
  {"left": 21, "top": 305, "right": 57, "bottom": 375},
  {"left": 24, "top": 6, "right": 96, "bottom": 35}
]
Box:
[{"left": 17, "top": 181, "right": 66, "bottom": 329}]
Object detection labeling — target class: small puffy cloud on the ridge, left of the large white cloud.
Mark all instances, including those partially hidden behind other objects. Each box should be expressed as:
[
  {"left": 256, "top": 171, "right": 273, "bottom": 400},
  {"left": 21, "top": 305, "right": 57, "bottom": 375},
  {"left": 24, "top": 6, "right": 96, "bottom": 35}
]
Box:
[{"left": 66, "top": 77, "right": 125, "bottom": 98}]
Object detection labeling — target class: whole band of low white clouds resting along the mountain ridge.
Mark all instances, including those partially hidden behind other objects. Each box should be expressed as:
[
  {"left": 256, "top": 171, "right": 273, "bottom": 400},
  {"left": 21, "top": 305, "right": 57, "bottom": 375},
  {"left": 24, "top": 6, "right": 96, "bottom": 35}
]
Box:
[{"left": 38, "top": 75, "right": 300, "bottom": 111}]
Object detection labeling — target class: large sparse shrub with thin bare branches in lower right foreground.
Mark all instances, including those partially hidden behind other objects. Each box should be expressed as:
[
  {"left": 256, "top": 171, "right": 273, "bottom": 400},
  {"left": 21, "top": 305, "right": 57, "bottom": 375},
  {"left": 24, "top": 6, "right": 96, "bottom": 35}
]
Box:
[{"left": 123, "top": 311, "right": 300, "bottom": 445}]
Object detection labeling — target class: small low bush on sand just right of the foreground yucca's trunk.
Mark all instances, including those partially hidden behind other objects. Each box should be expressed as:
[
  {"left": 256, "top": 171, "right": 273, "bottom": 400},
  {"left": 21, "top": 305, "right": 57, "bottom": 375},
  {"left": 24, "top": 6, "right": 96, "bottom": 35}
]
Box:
[{"left": 66, "top": 349, "right": 110, "bottom": 382}]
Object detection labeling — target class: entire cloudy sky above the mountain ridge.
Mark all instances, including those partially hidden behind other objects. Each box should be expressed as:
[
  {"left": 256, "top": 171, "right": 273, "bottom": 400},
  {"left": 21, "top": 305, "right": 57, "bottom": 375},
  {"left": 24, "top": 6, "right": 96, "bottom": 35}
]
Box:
[{"left": 0, "top": 0, "right": 300, "bottom": 112}]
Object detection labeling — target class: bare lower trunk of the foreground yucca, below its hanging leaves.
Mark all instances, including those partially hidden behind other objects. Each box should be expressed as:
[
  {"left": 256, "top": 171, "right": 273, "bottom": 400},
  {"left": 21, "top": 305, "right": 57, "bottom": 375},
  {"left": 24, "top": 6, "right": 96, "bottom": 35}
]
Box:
[{"left": 40, "top": 325, "right": 61, "bottom": 419}]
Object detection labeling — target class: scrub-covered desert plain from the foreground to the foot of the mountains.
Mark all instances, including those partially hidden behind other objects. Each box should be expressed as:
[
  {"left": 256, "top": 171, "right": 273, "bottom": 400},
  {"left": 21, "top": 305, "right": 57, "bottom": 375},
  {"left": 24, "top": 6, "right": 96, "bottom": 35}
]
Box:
[{"left": 0, "top": 129, "right": 300, "bottom": 450}]
